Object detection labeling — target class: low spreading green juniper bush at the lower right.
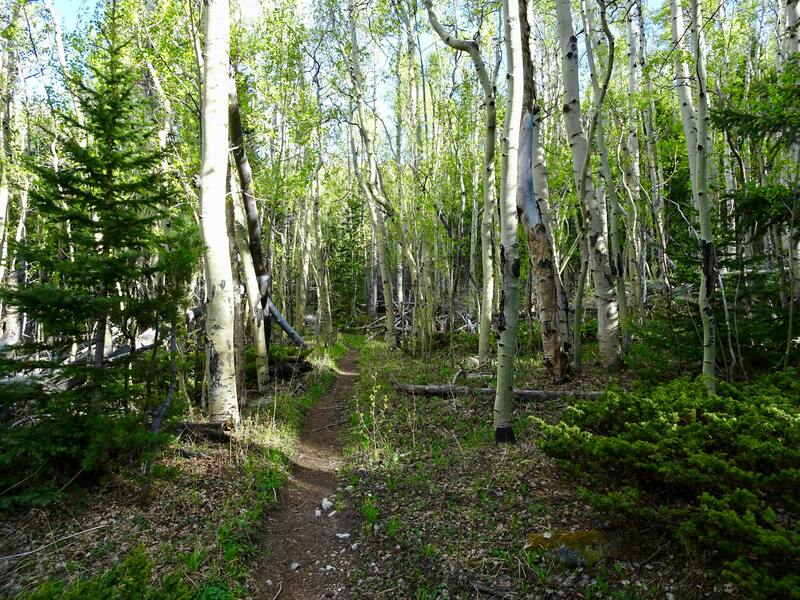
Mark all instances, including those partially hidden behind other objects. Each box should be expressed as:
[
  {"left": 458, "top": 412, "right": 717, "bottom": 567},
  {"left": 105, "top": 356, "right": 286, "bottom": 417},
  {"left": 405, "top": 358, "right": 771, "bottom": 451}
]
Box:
[{"left": 541, "top": 372, "right": 800, "bottom": 598}]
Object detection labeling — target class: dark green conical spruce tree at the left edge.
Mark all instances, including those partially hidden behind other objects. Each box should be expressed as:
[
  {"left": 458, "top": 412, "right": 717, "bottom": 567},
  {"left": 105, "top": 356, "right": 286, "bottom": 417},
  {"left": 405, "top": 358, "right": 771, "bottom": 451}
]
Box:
[{"left": 0, "top": 2, "right": 201, "bottom": 506}]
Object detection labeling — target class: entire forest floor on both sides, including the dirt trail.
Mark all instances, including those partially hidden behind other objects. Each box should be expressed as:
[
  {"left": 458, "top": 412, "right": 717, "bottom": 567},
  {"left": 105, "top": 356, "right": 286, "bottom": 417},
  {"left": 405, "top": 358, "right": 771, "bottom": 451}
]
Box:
[{"left": 0, "top": 336, "right": 736, "bottom": 600}]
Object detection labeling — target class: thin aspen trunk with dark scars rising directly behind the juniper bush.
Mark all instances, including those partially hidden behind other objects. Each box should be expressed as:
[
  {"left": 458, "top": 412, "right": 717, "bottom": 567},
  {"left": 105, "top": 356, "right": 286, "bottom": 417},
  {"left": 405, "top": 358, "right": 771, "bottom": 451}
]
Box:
[{"left": 688, "top": 0, "right": 717, "bottom": 392}]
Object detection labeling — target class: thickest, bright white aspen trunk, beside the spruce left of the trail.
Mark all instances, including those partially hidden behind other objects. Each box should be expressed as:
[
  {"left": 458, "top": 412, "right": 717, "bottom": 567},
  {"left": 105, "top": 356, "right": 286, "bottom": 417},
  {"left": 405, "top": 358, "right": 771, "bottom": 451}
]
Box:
[{"left": 200, "top": 0, "right": 240, "bottom": 426}]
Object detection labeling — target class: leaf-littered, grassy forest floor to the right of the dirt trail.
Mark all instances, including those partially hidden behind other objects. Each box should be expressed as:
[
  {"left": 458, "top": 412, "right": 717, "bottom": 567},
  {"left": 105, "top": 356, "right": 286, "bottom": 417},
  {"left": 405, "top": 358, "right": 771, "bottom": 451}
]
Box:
[{"left": 334, "top": 342, "right": 734, "bottom": 600}]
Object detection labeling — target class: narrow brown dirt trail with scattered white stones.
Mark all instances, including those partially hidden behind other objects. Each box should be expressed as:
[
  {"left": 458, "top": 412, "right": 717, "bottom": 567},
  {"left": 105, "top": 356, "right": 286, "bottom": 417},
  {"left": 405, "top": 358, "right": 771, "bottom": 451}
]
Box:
[{"left": 254, "top": 350, "right": 357, "bottom": 600}]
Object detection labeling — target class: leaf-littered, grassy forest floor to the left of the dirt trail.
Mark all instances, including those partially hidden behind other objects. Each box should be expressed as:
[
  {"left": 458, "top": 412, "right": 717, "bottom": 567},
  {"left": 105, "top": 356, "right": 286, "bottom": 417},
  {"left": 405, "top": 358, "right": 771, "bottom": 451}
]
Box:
[{"left": 0, "top": 345, "right": 346, "bottom": 600}]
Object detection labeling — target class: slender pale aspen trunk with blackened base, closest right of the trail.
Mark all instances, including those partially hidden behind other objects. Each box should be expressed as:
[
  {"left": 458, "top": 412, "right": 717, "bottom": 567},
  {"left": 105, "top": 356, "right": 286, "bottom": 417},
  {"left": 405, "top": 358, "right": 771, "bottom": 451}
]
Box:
[{"left": 494, "top": 0, "right": 523, "bottom": 443}]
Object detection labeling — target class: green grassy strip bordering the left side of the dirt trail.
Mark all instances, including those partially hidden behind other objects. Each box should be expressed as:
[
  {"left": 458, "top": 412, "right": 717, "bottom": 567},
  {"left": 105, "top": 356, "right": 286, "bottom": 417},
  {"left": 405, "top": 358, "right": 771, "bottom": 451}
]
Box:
[{"left": 17, "top": 340, "right": 347, "bottom": 600}]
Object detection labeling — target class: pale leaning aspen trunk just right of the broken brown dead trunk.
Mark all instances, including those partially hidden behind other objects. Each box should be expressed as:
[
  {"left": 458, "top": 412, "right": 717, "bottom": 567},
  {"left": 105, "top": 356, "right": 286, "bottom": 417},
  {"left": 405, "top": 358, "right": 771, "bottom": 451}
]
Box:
[{"left": 556, "top": 0, "right": 619, "bottom": 367}]
